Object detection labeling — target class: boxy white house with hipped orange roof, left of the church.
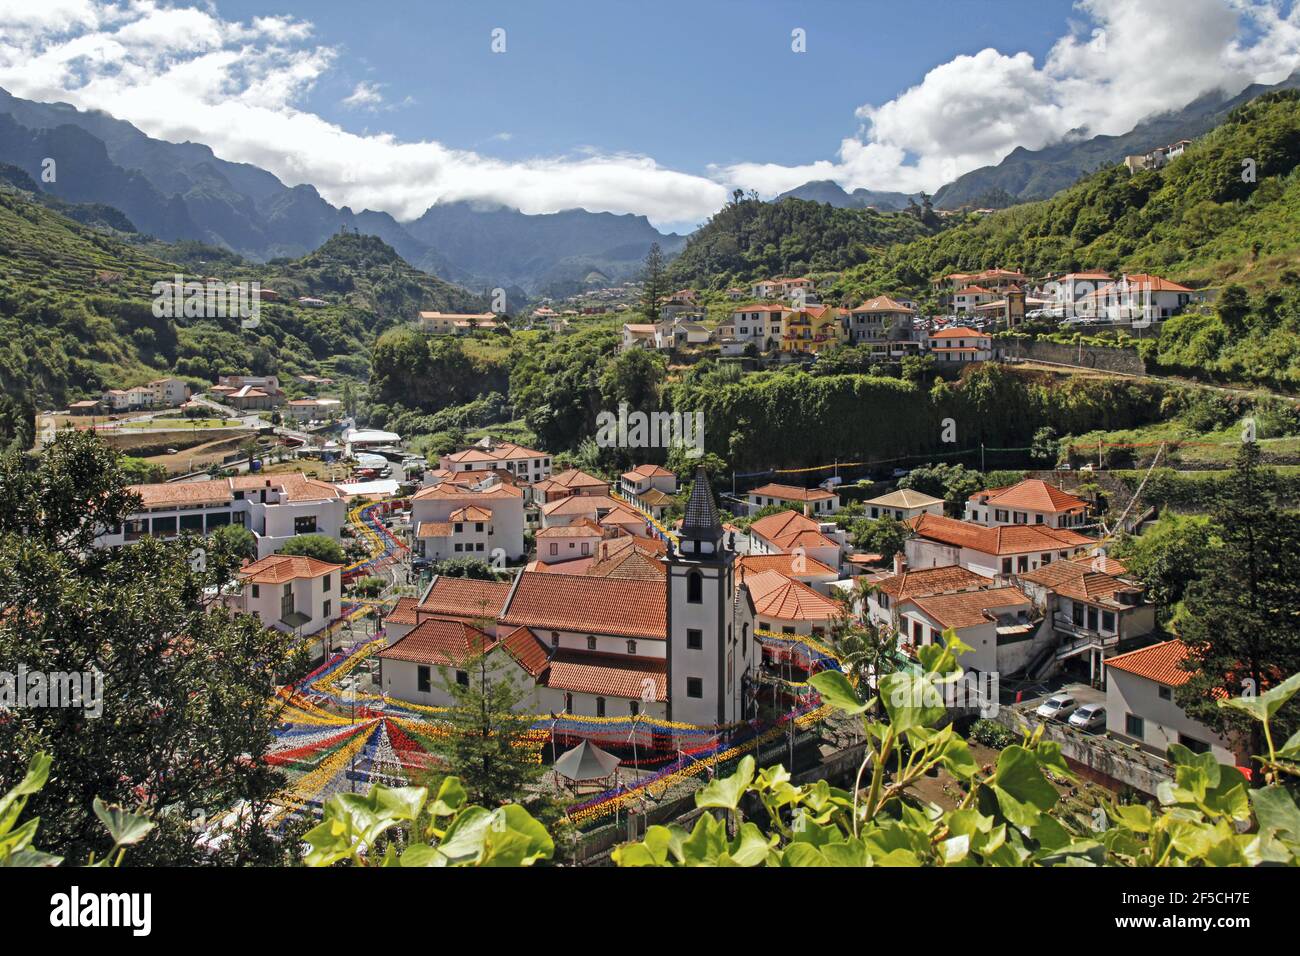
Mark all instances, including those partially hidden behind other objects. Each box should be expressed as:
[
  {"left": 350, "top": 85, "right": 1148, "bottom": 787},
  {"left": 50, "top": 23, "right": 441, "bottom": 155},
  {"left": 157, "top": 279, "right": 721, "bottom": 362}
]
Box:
[{"left": 238, "top": 554, "right": 343, "bottom": 636}]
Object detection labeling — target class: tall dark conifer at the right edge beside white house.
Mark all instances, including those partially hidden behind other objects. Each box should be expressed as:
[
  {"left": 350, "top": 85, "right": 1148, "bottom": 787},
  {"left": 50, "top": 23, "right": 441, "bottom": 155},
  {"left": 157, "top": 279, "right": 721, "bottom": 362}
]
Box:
[{"left": 1177, "top": 442, "right": 1300, "bottom": 783}]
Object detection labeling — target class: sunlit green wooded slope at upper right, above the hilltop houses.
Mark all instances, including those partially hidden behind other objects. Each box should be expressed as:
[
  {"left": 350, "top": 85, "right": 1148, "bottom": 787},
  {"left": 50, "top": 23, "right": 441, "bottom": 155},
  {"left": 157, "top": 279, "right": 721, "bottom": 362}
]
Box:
[{"left": 840, "top": 91, "right": 1300, "bottom": 298}]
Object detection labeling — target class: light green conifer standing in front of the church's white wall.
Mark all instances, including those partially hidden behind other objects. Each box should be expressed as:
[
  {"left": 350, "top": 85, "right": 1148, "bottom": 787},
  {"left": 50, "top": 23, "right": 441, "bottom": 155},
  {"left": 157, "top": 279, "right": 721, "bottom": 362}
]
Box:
[{"left": 441, "top": 650, "right": 542, "bottom": 808}]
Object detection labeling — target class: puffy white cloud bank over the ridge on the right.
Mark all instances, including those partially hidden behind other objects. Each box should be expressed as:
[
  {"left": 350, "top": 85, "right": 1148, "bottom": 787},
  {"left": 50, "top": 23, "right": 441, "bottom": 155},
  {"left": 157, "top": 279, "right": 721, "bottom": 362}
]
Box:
[{"left": 712, "top": 0, "right": 1300, "bottom": 195}]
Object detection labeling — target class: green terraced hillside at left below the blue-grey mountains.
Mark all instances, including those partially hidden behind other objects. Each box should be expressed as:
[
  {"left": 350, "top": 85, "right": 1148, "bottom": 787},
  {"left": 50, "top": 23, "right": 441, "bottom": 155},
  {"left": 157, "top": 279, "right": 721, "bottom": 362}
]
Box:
[{"left": 0, "top": 189, "right": 485, "bottom": 447}]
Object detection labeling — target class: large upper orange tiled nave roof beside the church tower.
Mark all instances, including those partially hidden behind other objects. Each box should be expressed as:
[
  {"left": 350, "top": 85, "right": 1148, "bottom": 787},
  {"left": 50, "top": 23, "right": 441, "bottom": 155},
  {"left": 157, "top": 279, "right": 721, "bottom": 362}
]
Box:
[{"left": 501, "top": 571, "right": 667, "bottom": 640}]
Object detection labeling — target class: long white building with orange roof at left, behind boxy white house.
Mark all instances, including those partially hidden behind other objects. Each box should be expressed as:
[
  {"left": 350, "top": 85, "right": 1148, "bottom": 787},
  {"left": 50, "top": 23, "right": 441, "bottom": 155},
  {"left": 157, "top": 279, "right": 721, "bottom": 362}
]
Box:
[{"left": 95, "top": 473, "right": 347, "bottom": 558}]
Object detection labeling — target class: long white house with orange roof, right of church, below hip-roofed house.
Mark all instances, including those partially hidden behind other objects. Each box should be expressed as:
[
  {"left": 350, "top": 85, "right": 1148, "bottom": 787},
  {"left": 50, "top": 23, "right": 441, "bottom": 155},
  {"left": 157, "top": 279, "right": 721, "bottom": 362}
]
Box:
[{"left": 904, "top": 514, "right": 1096, "bottom": 579}]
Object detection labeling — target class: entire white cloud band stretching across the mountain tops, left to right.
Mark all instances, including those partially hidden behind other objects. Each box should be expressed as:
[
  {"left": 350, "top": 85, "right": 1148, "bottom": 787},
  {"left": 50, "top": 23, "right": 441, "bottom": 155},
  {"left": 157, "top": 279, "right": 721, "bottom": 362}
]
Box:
[{"left": 0, "top": 0, "right": 1300, "bottom": 224}]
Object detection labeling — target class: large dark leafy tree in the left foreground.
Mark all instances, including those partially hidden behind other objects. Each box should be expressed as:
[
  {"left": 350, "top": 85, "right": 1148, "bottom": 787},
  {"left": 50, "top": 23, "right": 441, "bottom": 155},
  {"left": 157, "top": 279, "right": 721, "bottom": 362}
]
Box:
[{"left": 0, "top": 432, "right": 304, "bottom": 865}]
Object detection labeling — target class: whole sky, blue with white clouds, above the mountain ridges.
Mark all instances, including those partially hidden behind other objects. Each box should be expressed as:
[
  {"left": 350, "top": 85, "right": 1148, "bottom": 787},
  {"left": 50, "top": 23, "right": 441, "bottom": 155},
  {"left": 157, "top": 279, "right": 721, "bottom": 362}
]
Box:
[{"left": 0, "top": 0, "right": 1300, "bottom": 230}]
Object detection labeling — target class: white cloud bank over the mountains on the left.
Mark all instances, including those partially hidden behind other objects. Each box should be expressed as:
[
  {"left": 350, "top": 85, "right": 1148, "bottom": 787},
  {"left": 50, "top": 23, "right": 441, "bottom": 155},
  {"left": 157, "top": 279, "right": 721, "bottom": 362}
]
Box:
[{"left": 0, "top": 0, "right": 727, "bottom": 222}]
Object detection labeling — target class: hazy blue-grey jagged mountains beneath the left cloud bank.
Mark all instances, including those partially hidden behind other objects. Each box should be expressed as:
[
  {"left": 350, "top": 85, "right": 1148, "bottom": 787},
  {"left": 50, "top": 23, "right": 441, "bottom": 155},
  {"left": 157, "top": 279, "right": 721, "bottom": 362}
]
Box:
[{"left": 0, "top": 90, "right": 685, "bottom": 294}]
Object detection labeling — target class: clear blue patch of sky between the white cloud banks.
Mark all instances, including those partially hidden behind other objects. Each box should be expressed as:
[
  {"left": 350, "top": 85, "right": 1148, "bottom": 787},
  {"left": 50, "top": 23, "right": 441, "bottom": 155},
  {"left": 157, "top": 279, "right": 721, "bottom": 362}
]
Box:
[{"left": 220, "top": 0, "right": 1071, "bottom": 173}]
